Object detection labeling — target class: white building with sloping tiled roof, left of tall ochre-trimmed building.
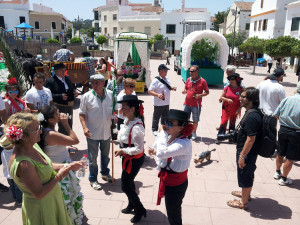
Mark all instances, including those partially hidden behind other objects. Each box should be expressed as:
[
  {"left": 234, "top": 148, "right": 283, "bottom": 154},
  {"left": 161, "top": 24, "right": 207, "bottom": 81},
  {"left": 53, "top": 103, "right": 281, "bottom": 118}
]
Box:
[{"left": 221, "top": 2, "right": 253, "bottom": 36}]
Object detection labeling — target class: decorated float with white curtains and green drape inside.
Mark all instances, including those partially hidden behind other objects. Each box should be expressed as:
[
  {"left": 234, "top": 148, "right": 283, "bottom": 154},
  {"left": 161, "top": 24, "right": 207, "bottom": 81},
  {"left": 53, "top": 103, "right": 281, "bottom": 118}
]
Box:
[{"left": 114, "top": 32, "right": 151, "bottom": 92}]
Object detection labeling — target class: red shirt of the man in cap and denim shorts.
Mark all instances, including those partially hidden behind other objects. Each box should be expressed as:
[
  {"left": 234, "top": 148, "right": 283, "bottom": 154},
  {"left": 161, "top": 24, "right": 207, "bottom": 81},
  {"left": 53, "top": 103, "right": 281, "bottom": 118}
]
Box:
[{"left": 184, "top": 77, "right": 208, "bottom": 107}]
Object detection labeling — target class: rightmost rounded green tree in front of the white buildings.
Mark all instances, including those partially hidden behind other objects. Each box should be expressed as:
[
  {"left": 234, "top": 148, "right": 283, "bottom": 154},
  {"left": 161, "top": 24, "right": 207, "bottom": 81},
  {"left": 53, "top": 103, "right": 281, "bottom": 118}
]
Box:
[{"left": 265, "top": 36, "right": 299, "bottom": 66}]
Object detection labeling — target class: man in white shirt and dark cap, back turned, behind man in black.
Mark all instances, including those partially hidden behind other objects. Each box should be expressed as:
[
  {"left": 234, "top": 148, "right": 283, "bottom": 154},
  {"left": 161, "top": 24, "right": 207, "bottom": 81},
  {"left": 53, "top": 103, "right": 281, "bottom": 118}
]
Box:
[{"left": 257, "top": 68, "right": 285, "bottom": 115}]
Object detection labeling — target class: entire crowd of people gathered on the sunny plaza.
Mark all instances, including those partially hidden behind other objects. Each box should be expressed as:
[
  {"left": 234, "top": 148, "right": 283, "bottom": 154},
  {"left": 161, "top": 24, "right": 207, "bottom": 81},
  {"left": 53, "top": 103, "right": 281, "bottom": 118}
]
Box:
[{"left": 0, "top": 47, "right": 300, "bottom": 225}]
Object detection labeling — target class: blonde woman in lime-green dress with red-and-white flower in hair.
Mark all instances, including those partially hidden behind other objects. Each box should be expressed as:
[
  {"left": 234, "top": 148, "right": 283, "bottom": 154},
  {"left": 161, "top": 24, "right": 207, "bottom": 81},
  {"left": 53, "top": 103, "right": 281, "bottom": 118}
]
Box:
[{"left": 4, "top": 113, "right": 82, "bottom": 225}]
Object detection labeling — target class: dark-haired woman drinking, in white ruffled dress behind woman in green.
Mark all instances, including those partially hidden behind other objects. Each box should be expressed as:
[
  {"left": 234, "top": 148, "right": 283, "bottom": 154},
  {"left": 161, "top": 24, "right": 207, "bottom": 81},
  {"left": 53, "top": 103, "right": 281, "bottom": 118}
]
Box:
[{"left": 39, "top": 105, "right": 84, "bottom": 225}]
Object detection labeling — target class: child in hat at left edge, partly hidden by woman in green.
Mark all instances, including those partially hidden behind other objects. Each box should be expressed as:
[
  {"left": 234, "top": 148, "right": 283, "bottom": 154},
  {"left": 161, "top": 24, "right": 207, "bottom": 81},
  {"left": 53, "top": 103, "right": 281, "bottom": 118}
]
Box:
[{"left": 0, "top": 135, "right": 23, "bottom": 206}]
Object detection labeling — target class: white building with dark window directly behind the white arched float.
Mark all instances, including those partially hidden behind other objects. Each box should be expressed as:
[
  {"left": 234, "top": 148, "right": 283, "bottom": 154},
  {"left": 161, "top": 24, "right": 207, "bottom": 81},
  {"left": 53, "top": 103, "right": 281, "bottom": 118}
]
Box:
[{"left": 160, "top": 9, "right": 211, "bottom": 54}]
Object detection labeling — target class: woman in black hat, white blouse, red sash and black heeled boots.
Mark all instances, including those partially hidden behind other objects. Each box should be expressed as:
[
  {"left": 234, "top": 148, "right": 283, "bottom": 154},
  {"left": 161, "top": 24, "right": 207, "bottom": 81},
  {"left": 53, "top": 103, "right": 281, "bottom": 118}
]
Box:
[{"left": 115, "top": 95, "right": 147, "bottom": 223}]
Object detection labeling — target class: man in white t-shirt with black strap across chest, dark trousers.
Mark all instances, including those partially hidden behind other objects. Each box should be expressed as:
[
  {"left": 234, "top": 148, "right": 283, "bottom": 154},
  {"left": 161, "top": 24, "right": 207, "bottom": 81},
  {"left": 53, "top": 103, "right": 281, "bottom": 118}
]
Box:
[{"left": 148, "top": 64, "right": 176, "bottom": 136}]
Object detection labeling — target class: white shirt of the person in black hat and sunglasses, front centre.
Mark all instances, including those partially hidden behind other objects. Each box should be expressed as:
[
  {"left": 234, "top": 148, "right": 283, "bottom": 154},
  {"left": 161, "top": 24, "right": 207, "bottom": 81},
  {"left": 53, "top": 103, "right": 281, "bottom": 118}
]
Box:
[{"left": 153, "top": 130, "right": 192, "bottom": 173}]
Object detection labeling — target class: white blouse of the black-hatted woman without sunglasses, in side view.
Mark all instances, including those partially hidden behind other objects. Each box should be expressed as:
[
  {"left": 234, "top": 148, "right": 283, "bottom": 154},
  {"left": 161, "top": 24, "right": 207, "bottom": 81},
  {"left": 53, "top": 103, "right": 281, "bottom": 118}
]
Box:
[{"left": 118, "top": 117, "right": 145, "bottom": 155}]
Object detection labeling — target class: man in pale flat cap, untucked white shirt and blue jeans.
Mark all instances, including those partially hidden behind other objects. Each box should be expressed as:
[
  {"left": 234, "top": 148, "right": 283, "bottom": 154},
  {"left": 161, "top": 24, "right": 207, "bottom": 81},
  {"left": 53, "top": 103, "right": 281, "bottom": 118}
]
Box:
[{"left": 79, "top": 74, "right": 113, "bottom": 190}]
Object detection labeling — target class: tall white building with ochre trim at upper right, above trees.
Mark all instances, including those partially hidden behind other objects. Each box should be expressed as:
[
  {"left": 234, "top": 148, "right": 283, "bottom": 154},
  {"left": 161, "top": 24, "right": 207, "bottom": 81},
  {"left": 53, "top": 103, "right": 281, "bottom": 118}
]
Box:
[{"left": 249, "top": 0, "right": 295, "bottom": 39}]
